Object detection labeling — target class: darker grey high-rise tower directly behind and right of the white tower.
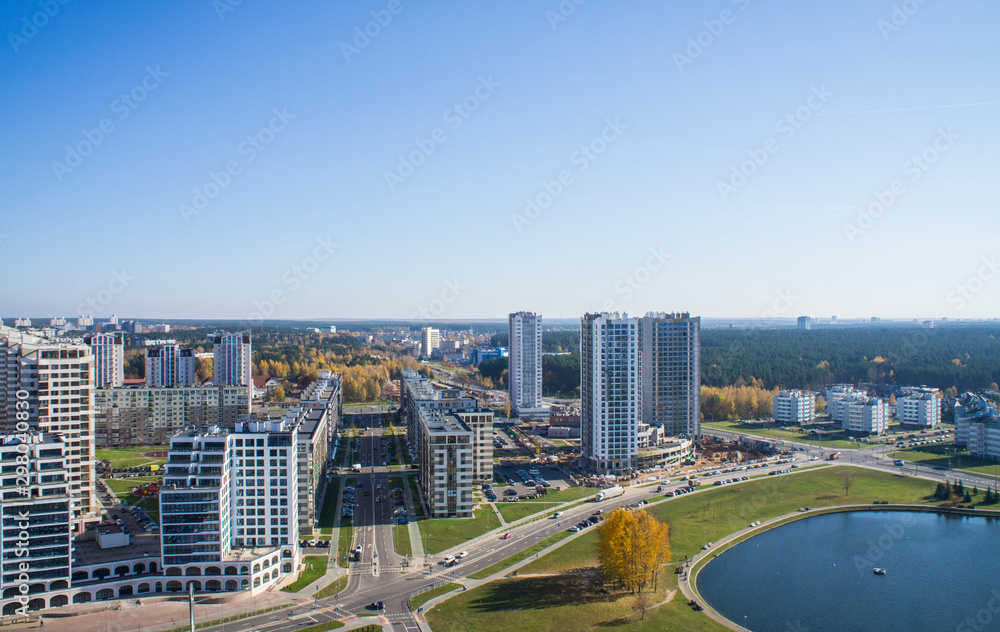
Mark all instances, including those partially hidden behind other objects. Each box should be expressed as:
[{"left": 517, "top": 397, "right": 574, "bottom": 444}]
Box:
[{"left": 639, "top": 312, "right": 701, "bottom": 437}]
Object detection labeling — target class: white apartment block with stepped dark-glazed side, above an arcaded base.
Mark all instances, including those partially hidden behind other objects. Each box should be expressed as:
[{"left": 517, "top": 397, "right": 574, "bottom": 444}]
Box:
[{"left": 160, "top": 420, "right": 299, "bottom": 594}]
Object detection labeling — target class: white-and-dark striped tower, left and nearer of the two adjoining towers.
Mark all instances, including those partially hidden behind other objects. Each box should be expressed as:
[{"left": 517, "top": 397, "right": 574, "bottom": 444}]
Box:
[{"left": 580, "top": 312, "right": 642, "bottom": 473}]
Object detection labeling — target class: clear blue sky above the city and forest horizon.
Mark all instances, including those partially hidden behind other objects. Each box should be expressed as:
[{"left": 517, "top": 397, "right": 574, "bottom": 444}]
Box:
[{"left": 0, "top": 0, "right": 1000, "bottom": 319}]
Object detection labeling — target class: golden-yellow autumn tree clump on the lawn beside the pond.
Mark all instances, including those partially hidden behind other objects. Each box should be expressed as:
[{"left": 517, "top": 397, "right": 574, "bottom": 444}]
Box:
[{"left": 597, "top": 509, "right": 670, "bottom": 593}]
